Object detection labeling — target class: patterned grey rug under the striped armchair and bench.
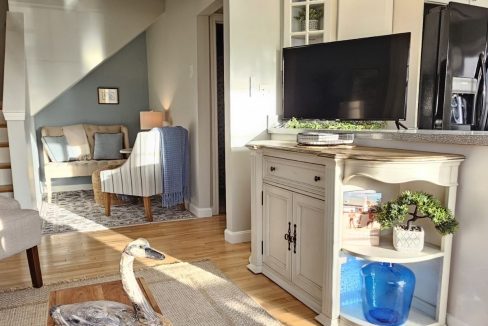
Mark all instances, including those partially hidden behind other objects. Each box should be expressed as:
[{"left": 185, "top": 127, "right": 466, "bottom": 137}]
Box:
[{"left": 40, "top": 190, "right": 194, "bottom": 234}]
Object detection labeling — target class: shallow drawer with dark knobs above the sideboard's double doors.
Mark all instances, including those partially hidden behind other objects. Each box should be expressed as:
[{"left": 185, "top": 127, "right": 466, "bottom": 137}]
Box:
[{"left": 263, "top": 156, "right": 325, "bottom": 193}]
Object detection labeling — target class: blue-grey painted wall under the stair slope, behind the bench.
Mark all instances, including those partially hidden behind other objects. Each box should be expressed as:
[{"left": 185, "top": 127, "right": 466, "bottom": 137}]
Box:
[{"left": 35, "top": 33, "right": 149, "bottom": 185}]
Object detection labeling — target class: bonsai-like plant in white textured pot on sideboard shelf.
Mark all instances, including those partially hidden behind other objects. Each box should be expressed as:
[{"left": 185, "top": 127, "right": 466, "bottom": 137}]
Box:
[{"left": 375, "top": 191, "right": 459, "bottom": 252}]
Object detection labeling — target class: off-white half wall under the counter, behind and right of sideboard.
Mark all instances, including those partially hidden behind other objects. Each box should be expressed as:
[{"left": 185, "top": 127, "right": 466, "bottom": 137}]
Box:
[{"left": 357, "top": 140, "right": 488, "bottom": 326}]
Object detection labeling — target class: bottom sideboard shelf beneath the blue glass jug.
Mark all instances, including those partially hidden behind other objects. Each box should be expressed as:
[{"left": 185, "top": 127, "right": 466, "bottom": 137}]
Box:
[{"left": 340, "top": 303, "right": 439, "bottom": 326}]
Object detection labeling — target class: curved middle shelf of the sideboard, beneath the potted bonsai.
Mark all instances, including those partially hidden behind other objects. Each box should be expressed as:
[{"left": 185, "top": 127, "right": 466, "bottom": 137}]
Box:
[{"left": 342, "top": 239, "right": 444, "bottom": 263}]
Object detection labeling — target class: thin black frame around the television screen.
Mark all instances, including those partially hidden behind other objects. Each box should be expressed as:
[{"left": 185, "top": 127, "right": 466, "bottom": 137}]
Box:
[{"left": 279, "top": 32, "right": 412, "bottom": 122}]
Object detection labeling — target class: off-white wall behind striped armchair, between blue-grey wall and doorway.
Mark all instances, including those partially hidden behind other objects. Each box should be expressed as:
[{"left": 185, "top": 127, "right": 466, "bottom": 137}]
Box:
[{"left": 146, "top": 0, "right": 214, "bottom": 216}]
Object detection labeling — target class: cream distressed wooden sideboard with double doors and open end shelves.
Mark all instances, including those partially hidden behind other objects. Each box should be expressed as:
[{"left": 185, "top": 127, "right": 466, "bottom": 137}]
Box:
[{"left": 248, "top": 141, "right": 464, "bottom": 326}]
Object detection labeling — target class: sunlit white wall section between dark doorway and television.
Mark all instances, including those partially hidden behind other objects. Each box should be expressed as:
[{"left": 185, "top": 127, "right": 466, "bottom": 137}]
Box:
[{"left": 224, "top": 0, "right": 282, "bottom": 242}]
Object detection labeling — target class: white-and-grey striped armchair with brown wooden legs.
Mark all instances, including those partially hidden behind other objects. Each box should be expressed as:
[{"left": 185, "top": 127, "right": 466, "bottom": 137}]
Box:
[{"left": 100, "top": 129, "right": 163, "bottom": 221}]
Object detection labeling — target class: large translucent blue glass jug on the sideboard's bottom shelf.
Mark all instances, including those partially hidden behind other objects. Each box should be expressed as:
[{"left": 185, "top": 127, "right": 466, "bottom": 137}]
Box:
[{"left": 361, "top": 262, "right": 415, "bottom": 326}]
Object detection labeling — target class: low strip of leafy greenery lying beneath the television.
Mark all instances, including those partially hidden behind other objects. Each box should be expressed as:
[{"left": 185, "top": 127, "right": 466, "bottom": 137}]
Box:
[{"left": 284, "top": 118, "right": 386, "bottom": 130}]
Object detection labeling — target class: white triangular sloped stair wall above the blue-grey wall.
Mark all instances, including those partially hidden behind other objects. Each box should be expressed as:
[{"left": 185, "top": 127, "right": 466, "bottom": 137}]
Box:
[{"left": 9, "top": 0, "right": 163, "bottom": 115}]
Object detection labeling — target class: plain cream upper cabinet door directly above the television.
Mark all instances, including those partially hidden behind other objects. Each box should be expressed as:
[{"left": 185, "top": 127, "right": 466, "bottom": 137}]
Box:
[{"left": 337, "top": 0, "right": 393, "bottom": 40}]
